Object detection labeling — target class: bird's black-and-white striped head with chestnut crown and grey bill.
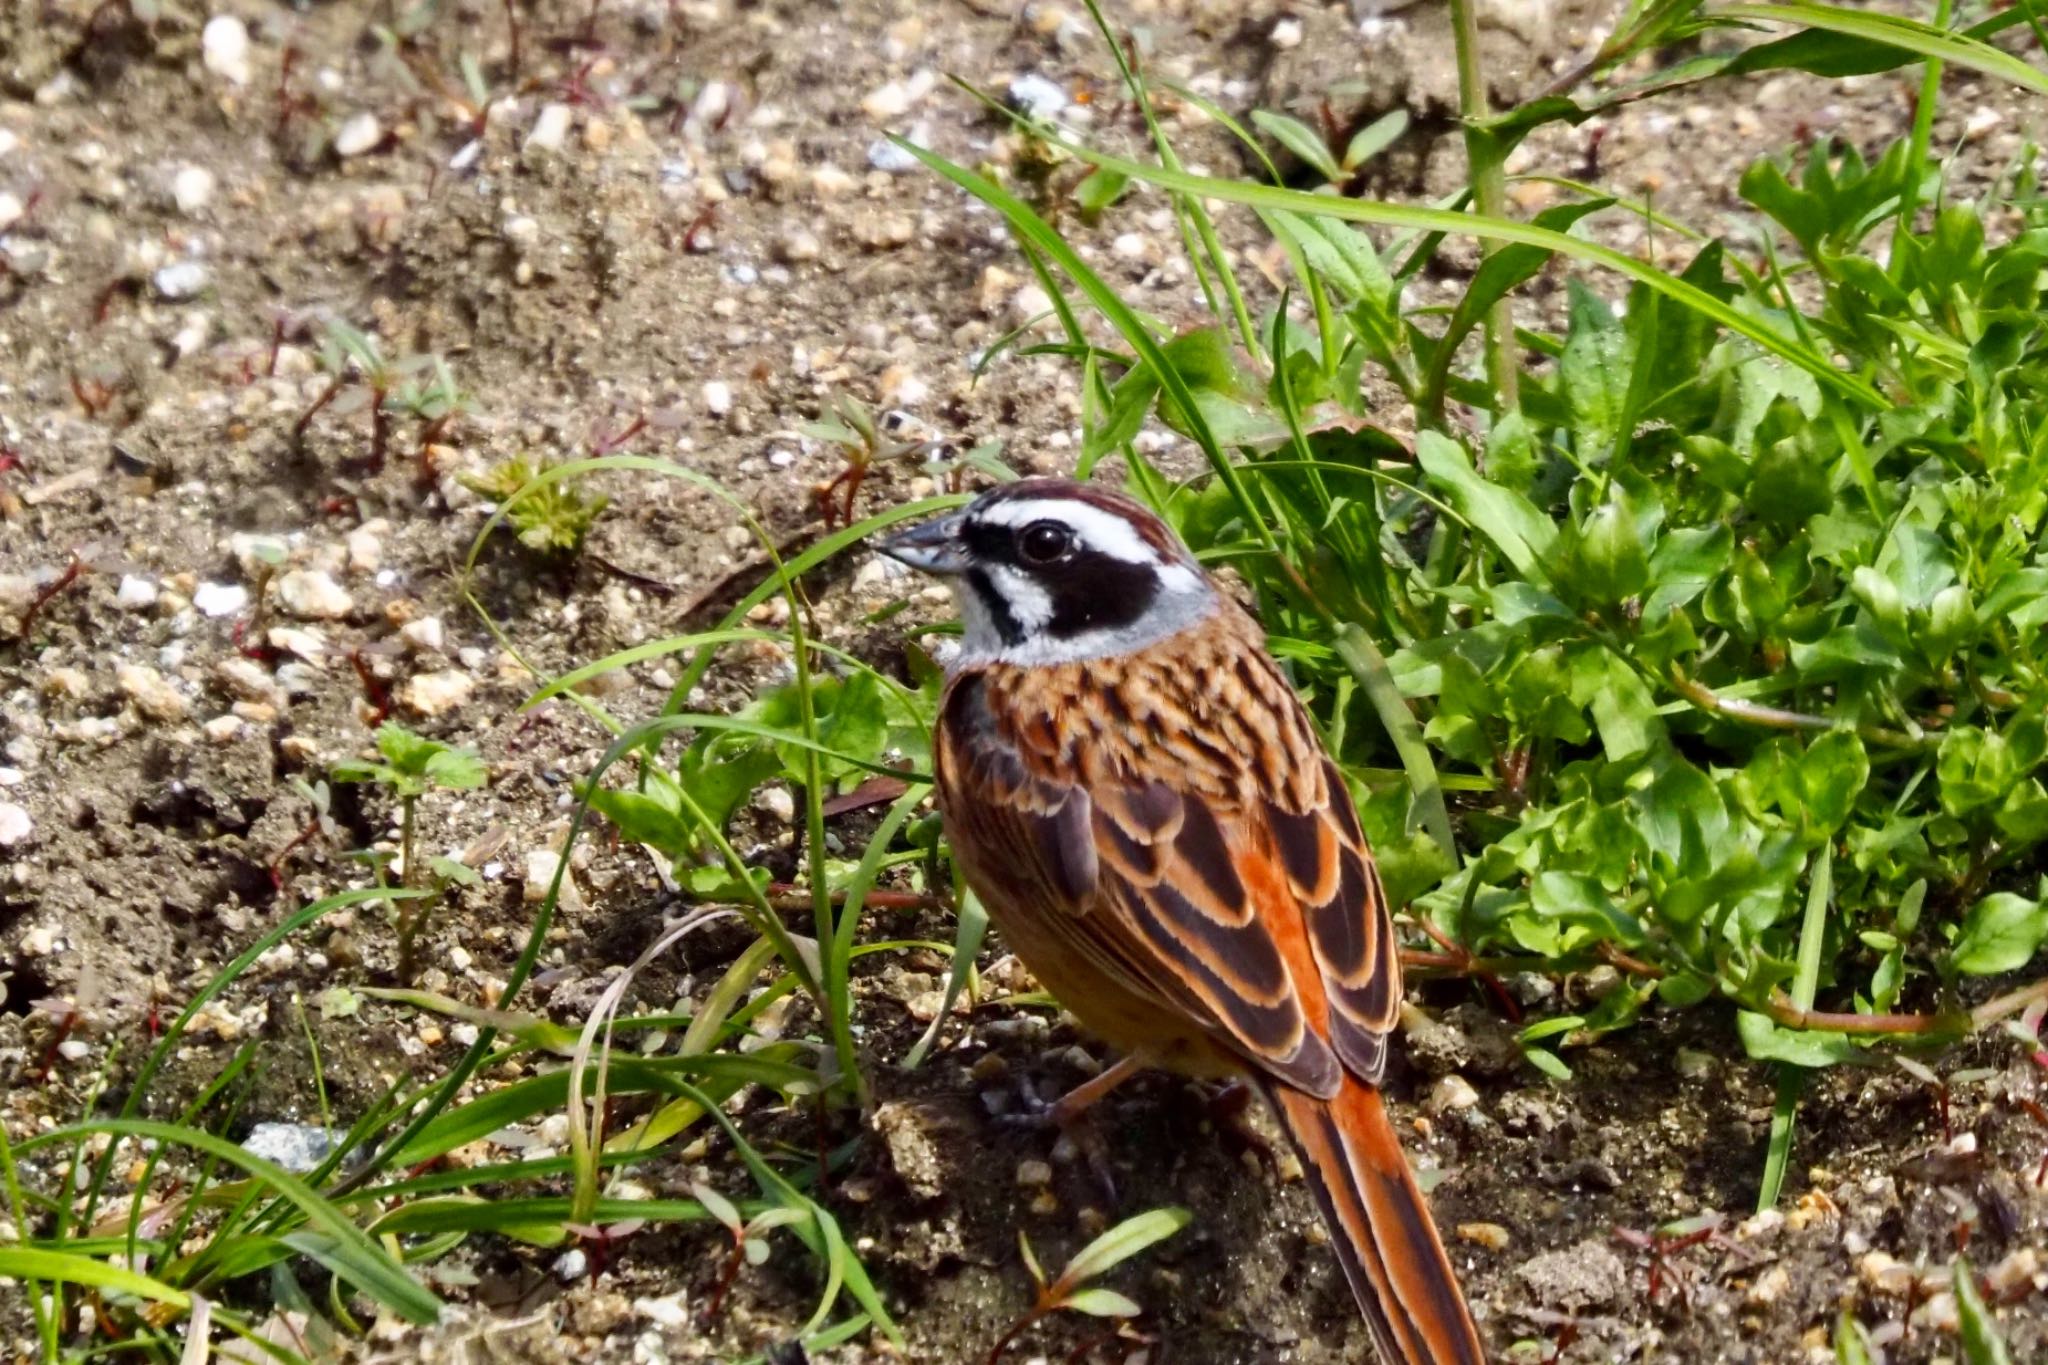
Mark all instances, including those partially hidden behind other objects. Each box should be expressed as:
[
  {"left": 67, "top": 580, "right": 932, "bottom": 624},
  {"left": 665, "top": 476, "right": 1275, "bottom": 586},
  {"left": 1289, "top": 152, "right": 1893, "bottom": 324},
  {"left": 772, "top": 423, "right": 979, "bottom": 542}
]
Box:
[{"left": 877, "top": 479, "right": 1221, "bottom": 665}]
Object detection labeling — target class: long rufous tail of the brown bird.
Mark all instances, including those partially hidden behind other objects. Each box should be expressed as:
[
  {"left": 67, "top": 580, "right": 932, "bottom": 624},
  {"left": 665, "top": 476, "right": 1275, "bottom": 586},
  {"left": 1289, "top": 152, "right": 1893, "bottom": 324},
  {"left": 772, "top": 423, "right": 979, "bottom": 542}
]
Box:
[{"left": 1266, "top": 1074, "right": 1487, "bottom": 1365}]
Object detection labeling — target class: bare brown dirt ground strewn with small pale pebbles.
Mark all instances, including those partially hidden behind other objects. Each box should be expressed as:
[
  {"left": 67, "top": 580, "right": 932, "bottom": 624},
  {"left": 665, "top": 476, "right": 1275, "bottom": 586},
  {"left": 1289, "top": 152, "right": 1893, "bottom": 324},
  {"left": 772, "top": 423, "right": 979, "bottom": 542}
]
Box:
[{"left": 0, "top": 0, "right": 2048, "bottom": 1365}]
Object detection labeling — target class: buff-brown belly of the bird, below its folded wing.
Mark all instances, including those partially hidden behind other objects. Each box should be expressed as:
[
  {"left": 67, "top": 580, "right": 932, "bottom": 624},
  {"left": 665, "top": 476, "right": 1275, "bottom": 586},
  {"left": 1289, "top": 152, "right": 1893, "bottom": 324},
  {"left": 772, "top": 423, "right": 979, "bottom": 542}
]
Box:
[{"left": 971, "top": 892, "right": 1243, "bottom": 1076}]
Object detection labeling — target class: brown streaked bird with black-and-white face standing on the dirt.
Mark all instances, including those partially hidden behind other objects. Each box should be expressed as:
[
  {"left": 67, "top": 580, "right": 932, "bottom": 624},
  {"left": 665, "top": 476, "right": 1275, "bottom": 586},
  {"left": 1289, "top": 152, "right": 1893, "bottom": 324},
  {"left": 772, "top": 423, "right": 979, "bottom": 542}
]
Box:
[{"left": 877, "top": 479, "right": 1485, "bottom": 1365}]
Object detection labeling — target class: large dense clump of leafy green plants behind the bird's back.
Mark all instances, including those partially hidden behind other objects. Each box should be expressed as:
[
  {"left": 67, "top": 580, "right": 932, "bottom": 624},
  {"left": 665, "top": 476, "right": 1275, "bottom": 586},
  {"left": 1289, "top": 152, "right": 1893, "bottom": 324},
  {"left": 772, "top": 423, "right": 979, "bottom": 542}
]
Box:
[{"left": 909, "top": 6, "right": 2048, "bottom": 1199}]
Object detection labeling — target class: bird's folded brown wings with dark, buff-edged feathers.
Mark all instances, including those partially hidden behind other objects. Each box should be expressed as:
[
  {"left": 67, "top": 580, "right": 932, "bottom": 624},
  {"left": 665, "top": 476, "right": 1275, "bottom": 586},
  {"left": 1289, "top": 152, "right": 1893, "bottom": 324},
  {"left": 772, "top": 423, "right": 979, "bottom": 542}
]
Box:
[{"left": 938, "top": 673, "right": 1401, "bottom": 1099}]
